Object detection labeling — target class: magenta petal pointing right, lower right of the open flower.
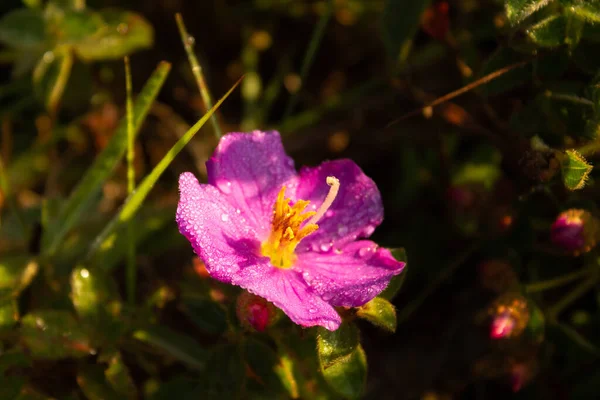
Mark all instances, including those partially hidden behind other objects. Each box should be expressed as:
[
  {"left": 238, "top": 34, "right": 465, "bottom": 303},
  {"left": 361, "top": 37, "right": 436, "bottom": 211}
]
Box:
[{"left": 294, "top": 240, "right": 405, "bottom": 307}]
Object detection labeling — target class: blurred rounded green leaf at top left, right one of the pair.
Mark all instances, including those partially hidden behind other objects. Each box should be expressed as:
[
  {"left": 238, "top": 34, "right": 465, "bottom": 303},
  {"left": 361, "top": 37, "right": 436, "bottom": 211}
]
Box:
[{"left": 74, "top": 10, "right": 154, "bottom": 61}]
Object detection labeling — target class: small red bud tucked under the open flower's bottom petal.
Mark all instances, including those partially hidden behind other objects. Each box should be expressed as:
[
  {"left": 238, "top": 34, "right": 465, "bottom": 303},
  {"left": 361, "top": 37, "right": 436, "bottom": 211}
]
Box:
[{"left": 236, "top": 292, "right": 278, "bottom": 332}]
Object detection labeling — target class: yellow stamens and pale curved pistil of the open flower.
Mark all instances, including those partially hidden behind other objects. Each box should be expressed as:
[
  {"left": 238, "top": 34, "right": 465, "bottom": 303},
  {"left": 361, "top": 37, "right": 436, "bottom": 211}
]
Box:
[{"left": 261, "top": 176, "right": 340, "bottom": 268}]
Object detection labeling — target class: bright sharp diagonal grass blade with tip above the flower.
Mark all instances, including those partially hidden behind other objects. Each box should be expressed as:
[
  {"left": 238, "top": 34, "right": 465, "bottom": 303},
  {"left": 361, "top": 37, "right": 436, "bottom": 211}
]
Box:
[{"left": 88, "top": 77, "right": 243, "bottom": 261}]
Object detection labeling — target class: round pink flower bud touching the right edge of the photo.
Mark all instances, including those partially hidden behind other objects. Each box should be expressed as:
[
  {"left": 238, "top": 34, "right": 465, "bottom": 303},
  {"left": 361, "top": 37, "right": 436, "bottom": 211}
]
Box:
[{"left": 550, "top": 209, "right": 597, "bottom": 255}]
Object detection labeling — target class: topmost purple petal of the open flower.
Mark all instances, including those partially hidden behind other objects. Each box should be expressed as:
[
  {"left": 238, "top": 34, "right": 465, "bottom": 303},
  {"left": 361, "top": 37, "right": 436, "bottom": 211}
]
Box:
[{"left": 206, "top": 131, "right": 296, "bottom": 238}]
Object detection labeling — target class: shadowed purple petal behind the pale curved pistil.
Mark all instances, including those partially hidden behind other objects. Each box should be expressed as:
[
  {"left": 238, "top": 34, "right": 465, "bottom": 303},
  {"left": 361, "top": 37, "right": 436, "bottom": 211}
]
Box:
[{"left": 296, "top": 160, "right": 383, "bottom": 252}]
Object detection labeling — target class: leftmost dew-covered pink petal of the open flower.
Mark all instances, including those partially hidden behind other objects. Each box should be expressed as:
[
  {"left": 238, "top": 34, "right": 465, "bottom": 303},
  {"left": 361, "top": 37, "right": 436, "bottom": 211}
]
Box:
[{"left": 176, "top": 172, "right": 261, "bottom": 283}]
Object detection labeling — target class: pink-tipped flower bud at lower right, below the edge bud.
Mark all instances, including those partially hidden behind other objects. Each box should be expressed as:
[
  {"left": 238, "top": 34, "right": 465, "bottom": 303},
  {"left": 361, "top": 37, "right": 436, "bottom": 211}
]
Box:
[{"left": 489, "top": 293, "right": 530, "bottom": 340}]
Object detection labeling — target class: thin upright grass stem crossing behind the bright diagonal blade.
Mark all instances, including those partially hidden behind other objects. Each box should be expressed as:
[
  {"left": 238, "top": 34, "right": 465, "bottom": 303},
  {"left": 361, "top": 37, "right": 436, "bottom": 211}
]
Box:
[{"left": 125, "top": 56, "right": 137, "bottom": 306}]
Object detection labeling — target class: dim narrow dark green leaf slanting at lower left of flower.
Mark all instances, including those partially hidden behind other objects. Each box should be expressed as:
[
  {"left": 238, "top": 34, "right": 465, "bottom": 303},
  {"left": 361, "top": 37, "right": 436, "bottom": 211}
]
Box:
[{"left": 133, "top": 326, "right": 210, "bottom": 370}]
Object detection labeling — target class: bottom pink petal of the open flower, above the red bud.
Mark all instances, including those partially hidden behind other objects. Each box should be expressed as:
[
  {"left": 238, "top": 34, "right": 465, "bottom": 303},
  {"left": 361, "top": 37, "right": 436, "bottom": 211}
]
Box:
[{"left": 233, "top": 257, "right": 342, "bottom": 331}]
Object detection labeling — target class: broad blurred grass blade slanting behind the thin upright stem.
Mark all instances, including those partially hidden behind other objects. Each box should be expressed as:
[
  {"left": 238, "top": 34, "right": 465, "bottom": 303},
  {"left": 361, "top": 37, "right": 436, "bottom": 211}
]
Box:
[{"left": 42, "top": 61, "right": 171, "bottom": 257}]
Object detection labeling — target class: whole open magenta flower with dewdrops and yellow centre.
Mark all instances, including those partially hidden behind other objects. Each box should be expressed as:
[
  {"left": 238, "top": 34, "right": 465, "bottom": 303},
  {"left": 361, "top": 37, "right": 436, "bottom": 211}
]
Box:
[{"left": 176, "top": 131, "right": 405, "bottom": 330}]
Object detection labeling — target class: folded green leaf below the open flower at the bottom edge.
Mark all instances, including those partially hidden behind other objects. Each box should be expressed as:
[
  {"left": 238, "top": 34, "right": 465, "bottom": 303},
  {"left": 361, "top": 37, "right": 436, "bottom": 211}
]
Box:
[{"left": 317, "top": 323, "right": 367, "bottom": 399}]
